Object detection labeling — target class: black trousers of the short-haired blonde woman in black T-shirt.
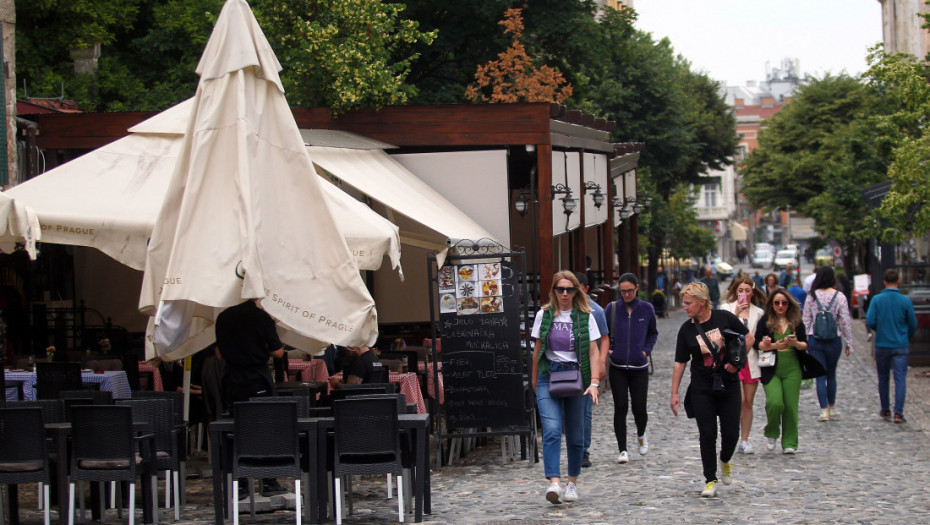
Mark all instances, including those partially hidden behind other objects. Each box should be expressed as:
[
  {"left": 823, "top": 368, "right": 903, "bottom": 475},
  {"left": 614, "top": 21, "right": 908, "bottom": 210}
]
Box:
[{"left": 691, "top": 382, "right": 743, "bottom": 482}]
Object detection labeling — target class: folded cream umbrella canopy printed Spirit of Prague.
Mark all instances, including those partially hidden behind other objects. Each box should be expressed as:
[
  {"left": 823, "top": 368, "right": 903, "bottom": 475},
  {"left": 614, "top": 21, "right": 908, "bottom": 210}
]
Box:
[{"left": 139, "top": 0, "right": 377, "bottom": 358}]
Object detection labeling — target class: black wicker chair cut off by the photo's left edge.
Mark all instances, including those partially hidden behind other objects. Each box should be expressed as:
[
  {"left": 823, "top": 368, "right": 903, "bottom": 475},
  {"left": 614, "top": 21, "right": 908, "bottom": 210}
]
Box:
[{"left": 0, "top": 407, "right": 51, "bottom": 525}]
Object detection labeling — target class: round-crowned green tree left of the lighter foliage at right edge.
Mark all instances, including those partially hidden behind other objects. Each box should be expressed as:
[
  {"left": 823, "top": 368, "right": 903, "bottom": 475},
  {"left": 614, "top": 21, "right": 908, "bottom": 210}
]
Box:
[{"left": 743, "top": 75, "right": 886, "bottom": 265}]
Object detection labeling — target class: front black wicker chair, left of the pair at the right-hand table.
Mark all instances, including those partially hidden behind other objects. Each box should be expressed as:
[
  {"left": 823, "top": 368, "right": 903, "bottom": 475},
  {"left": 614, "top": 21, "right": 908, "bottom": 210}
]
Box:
[{"left": 230, "top": 400, "right": 301, "bottom": 525}]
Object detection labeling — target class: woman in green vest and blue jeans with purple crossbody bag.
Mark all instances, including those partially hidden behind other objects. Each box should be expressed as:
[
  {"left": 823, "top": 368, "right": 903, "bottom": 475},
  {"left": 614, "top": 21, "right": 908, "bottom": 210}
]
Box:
[{"left": 532, "top": 271, "right": 601, "bottom": 503}]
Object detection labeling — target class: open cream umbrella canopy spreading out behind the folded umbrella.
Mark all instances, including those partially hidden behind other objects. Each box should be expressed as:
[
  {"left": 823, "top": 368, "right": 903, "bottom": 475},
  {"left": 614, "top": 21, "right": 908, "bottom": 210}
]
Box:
[{"left": 0, "top": 98, "right": 400, "bottom": 270}]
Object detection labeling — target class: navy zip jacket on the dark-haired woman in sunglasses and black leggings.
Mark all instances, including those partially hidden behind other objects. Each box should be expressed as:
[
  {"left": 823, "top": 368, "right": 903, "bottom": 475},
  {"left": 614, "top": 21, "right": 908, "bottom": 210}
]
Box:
[{"left": 604, "top": 298, "right": 659, "bottom": 368}]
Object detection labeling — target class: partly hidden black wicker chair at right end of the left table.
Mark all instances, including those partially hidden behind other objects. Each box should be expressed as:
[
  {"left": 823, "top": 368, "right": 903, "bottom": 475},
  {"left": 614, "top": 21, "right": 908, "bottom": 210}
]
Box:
[{"left": 116, "top": 397, "right": 181, "bottom": 521}]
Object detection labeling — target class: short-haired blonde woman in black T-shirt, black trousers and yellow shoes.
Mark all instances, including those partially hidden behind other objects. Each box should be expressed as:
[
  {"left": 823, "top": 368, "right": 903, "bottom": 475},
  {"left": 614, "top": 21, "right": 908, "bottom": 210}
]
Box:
[{"left": 669, "top": 283, "right": 754, "bottom": 498}]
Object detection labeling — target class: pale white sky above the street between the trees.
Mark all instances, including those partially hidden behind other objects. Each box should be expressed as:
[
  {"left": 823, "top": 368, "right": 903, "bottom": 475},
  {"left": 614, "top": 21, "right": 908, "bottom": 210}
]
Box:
[{"left": 633, "top": 0, "right": 882, "bottom": 86}]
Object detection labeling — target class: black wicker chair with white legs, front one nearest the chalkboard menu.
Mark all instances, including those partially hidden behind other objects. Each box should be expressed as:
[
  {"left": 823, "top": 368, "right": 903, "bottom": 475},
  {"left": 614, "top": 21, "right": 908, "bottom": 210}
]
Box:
[{"left": 333, "top": 397, "right": 404, "bottom": 525}]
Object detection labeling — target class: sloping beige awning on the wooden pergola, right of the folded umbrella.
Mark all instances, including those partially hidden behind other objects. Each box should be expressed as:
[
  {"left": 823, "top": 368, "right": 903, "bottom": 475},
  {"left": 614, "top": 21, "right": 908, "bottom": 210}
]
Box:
[{"left": 307, "top": 146, "right": 497, "bottom": 264}]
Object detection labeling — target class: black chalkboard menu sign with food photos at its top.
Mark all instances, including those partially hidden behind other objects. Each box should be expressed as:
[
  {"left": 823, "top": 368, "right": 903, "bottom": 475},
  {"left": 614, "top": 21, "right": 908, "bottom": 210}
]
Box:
[{"left": 438, "top": 261, "right": 526, "bottom": 430}]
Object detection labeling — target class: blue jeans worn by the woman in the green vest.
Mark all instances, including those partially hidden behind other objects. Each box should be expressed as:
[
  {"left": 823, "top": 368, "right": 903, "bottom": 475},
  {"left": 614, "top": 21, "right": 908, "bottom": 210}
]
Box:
[{"left": 536, "top": 364, "right": 585, "bottom": 478}]
